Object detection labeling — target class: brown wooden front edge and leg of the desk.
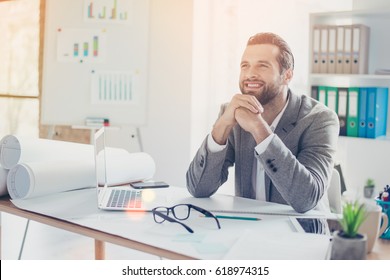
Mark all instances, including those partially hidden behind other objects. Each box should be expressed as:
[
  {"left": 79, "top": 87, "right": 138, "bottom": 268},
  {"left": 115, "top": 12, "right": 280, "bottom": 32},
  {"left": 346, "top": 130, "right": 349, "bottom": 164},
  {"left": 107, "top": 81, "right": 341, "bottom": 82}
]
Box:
[{"left": 0, "top": 197, "right": 193, "bottom": 260}]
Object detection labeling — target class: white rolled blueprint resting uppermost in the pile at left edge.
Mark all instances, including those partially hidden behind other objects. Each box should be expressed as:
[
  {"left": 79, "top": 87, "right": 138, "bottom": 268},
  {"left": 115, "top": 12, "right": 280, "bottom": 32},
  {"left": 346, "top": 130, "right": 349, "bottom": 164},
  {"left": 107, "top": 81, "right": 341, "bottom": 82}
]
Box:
[{"left": 0, "top": 135, "right": 94, "bottom": 169}]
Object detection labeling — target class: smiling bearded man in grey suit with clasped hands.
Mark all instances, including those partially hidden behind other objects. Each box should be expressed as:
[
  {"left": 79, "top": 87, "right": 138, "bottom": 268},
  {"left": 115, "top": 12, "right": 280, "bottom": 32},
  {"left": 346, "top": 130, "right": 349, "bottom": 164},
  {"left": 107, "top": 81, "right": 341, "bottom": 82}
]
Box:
[{"left": 187, "top": 33, "right": 339, "bottom": 213}]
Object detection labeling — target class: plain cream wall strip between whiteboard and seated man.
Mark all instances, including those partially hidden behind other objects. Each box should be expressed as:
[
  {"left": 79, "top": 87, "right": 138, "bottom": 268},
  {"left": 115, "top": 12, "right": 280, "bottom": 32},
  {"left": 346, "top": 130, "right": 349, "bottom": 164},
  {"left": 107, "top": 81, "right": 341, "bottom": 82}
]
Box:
[{"left": 141, "top": 0, "right": 193, "bottom": 186}]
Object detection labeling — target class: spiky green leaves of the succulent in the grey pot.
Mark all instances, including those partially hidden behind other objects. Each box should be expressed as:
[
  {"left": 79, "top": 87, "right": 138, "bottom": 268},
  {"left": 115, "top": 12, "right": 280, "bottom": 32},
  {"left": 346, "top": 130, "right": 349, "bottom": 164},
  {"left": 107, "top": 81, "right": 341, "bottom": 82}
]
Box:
[{"left": 339, "top": 201, "right": 367, "bottom": 238}]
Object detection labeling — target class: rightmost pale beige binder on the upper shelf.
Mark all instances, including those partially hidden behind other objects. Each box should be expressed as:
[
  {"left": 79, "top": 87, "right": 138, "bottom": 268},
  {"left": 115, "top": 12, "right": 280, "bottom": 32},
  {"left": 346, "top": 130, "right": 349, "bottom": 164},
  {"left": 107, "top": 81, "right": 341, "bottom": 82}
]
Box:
[{"left": 351, "top": 24, "right": 370, "bottom": 74}]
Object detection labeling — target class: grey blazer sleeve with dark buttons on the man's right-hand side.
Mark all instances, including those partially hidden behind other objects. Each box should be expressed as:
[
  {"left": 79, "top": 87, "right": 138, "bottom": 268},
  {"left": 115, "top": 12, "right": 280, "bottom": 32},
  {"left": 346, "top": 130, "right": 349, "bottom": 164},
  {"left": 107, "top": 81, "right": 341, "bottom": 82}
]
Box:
[{"left": 256, "top": 106, "right": 339, "bottom": 213}]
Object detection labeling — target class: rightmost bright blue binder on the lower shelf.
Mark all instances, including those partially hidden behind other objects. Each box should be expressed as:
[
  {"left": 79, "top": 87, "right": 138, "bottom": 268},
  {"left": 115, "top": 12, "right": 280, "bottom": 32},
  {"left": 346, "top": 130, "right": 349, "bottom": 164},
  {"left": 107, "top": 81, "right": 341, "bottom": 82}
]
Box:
[{"left": 367, "top": 87, "right": 389, "bottom": 138}]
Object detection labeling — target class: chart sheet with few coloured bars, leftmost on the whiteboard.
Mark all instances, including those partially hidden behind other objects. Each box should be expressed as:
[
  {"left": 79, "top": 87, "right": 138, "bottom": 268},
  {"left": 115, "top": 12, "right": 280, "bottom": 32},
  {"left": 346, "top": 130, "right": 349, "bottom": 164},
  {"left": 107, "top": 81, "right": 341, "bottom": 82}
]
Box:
[{"left": 57, "top": 28, "right": 106, "bottom": 63}]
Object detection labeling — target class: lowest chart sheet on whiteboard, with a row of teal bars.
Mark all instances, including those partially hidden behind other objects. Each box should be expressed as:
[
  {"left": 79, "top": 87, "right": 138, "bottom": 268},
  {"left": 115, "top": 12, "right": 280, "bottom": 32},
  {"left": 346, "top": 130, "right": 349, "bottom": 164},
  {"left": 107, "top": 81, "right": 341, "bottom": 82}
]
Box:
[{"left": 91, "top": 71, "right": 136, "bottom": 104}]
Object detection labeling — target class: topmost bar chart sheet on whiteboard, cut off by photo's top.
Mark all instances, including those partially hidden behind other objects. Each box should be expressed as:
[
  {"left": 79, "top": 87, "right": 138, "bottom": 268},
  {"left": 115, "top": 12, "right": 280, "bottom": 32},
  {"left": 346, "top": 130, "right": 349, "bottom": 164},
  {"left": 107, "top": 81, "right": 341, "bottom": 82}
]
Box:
[{"left": 84, "top": 0, "right": 132, "bottom": 23}]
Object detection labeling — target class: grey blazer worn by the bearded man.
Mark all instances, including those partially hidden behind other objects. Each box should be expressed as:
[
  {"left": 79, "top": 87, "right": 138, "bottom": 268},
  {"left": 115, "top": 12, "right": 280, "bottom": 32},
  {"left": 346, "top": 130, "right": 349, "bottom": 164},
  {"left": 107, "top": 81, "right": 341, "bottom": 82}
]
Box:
[{"left": 186, "top": 91, "right": 339, "bottom": 213}]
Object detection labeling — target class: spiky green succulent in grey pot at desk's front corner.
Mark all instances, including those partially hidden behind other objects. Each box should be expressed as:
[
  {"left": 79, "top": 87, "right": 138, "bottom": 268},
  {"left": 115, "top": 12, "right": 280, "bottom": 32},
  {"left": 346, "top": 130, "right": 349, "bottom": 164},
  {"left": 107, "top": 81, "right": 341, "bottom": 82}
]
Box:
[{"left": 331, "top": 201, "right": 367, "bottom": 260}]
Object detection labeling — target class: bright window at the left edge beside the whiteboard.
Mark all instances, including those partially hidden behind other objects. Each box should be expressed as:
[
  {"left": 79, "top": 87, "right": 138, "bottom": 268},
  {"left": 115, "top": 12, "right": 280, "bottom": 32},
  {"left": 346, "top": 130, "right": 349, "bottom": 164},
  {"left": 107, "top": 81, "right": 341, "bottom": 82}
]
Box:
[{"left": 0, "top": 0, "right": 44, "bottom": 138}]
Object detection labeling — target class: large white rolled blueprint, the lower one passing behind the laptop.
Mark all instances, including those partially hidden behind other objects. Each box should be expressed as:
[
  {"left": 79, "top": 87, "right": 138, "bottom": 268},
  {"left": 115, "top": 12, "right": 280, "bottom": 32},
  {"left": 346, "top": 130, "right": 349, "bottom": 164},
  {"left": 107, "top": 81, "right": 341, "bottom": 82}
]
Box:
[{"left": 7, "top": 151, "right": 155, "bottom": 199}]
